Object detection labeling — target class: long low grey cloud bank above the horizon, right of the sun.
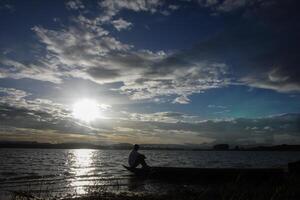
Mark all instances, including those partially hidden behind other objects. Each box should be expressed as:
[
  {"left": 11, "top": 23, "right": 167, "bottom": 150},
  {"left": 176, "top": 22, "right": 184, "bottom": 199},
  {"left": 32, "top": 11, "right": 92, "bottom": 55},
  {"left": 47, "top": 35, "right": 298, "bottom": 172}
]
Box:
[{"left": 89, "top": 112, "right": 300, "bottom": 145}]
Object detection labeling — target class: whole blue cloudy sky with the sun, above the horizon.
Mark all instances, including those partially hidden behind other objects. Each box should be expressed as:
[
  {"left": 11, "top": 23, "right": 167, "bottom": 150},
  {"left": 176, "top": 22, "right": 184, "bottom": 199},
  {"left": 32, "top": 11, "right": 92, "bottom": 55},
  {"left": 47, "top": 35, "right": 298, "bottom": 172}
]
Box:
[{"left": 0, "top": 0, "right": 300, "bottom": 145}]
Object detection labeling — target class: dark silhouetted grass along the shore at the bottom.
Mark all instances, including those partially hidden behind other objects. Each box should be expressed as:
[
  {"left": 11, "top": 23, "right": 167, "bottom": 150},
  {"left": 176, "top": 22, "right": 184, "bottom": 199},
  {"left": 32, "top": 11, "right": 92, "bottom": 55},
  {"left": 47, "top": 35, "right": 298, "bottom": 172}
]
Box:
[{"left": 11, "top": 175, "right": 300, "bottom": 200}]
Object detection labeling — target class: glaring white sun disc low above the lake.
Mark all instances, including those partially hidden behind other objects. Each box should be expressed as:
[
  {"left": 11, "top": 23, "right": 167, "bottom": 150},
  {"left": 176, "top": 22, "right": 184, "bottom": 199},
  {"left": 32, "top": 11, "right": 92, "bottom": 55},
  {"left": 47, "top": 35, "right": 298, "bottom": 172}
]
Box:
[{"left": 72, "top": 99, "right": 101, "bottom": 122}]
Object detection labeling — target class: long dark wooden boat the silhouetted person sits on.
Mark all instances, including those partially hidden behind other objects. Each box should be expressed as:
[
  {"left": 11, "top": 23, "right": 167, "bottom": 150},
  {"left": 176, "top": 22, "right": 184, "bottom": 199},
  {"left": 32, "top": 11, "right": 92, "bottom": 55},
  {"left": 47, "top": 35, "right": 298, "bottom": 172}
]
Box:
[{"left": 123, "top": 165, "right": 285, "bottom": 182}]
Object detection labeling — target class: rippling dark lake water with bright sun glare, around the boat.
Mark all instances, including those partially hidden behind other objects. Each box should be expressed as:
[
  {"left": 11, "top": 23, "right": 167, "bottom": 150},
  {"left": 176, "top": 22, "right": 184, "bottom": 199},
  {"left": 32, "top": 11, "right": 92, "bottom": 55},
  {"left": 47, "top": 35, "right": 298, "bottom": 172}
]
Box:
[{"left": 0, "top": 149, "right": 300, "bottom": 199}]
